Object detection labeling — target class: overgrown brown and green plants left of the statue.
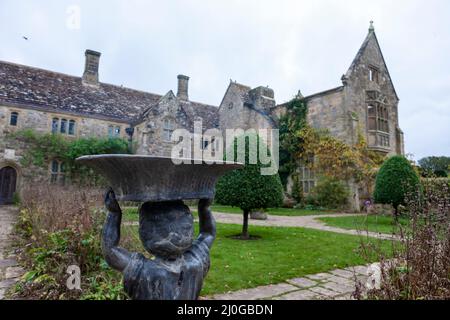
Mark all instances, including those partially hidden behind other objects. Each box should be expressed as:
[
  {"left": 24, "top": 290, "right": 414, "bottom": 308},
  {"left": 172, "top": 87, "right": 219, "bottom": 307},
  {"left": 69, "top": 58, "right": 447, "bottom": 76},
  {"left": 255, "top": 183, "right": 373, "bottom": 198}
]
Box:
[{"left": 10, "top": 185, "right": 126, "bottom": 300}]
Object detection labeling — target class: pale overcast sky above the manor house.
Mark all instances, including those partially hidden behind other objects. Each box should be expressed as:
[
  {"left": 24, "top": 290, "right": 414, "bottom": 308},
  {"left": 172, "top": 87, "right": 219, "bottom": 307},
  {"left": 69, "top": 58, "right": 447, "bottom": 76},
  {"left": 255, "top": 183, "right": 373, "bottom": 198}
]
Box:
[{"left": 0, "top": 0, "right": 450, "bottom": 160}]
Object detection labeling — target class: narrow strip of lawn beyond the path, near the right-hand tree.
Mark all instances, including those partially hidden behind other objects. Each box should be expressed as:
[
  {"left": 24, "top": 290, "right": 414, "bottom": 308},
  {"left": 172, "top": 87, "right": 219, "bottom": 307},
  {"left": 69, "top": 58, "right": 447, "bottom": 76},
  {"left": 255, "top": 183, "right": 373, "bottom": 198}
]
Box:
[{"left": 319, "top": 215, "right": 409, "bottom": 234}]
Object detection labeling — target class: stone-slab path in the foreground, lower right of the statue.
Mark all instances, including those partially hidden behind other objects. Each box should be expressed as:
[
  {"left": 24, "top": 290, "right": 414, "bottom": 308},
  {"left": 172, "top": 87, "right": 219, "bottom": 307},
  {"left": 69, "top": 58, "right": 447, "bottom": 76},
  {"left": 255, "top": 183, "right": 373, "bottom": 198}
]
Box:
[{"left": 207, "top": 266, "right": 368, "bottom": 300}]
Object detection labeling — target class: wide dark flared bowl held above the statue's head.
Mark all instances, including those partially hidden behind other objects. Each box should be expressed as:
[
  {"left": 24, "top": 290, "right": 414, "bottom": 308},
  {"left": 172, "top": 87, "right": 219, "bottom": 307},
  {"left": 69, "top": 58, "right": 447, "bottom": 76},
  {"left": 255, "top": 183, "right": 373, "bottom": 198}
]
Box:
[{"left": 76, "top": 154, "right": 243, "bottom": 202}]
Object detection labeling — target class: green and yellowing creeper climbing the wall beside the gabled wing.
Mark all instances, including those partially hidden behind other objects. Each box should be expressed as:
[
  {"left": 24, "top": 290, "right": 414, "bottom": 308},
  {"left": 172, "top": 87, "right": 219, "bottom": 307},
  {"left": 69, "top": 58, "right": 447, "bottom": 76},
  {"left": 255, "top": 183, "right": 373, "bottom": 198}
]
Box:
[{"left": 279, "top": 97, "right": 385, "bottom": 195}]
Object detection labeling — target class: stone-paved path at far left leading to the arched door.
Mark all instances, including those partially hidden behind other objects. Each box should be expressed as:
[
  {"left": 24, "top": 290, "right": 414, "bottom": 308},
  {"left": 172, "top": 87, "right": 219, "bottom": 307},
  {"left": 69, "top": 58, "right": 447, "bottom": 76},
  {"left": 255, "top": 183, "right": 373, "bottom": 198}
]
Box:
[{"left": 0, "top": 206, "right": 23, "bottom": 300}]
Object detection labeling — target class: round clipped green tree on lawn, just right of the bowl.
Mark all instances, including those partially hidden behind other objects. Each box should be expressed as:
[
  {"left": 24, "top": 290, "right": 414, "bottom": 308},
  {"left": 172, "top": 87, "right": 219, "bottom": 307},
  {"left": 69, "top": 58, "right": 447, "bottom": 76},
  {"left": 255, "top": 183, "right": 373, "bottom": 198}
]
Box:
[{"left": 215, "top": 135, "right": 283, "bottom": 240}]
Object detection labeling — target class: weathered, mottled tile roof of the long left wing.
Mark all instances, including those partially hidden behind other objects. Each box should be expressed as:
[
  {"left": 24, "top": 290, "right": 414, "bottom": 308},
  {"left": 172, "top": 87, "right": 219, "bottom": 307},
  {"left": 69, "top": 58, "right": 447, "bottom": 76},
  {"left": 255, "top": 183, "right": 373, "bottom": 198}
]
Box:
[{"left": 0, "top": 61, "right": 218, "bottom": 125}]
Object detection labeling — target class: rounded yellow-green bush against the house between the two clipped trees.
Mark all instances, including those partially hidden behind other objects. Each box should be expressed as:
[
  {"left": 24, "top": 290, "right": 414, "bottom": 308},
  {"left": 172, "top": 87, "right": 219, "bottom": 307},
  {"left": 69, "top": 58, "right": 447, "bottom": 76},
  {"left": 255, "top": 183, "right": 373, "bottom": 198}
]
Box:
[{"left": 313, "top": 177, "right": 350, "bottom": 209}]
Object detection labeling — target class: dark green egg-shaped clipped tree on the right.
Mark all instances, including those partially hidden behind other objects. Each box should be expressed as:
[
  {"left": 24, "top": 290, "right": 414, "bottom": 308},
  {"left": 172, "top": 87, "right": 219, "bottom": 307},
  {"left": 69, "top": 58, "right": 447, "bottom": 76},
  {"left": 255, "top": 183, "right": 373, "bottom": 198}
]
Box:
[{"left": 374, "top": 156, "right": 420, "bottom": 217}]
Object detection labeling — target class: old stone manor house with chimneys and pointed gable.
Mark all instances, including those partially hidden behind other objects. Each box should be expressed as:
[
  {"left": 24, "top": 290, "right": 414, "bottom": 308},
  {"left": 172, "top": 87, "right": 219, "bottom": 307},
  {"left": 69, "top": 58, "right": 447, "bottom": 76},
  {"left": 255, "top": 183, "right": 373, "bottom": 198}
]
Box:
[{"left": 0, "top": 25, "right": 404, "bottom": 209}]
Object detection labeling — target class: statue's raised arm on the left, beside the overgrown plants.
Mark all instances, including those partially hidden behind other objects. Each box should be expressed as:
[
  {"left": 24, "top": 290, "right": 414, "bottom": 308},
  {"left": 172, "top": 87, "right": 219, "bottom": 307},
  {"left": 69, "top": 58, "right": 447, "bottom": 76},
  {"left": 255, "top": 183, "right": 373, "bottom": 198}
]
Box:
[{"left": 102, "top": 189, "right": 131, "bottom": 271}]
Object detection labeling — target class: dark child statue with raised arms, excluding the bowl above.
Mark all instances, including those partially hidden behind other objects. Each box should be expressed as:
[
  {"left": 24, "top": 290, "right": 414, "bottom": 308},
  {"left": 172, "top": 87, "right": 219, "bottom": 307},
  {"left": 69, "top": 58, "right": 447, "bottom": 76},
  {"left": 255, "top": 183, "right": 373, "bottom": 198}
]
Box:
[{"left": 102, "top": 189, "right": 216, "bottom": 300}]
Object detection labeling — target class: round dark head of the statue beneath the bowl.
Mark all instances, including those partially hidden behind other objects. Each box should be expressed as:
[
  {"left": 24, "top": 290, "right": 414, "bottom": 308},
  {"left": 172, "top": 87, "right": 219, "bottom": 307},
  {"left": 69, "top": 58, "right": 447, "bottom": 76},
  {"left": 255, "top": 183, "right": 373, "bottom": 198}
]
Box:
[{"left": 139, "top": 201, "right": 194, "bottom": 259}]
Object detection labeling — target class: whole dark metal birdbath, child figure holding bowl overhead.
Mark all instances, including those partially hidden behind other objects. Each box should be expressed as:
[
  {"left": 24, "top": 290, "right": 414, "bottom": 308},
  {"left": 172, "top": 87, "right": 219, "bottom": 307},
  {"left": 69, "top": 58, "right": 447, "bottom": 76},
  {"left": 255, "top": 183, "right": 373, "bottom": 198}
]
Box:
[{"left": 77, "top": 155, "right": 242, "bottom": 300}]
